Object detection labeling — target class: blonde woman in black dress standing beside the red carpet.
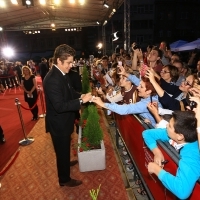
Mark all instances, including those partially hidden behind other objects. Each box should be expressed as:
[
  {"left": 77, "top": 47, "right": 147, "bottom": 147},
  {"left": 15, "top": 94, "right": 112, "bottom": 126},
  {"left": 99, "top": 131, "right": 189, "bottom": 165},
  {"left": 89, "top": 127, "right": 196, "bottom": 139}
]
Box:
[{"left": 21, "top": 66, "right": 38, "bottom": 120}]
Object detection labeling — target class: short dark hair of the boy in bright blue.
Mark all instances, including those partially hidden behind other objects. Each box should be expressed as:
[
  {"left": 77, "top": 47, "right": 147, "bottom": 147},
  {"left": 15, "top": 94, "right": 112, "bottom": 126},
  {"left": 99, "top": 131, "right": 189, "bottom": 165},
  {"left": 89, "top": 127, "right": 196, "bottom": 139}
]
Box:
[{"left": 172, "top": 111, "right": 197, "bottom": 142}]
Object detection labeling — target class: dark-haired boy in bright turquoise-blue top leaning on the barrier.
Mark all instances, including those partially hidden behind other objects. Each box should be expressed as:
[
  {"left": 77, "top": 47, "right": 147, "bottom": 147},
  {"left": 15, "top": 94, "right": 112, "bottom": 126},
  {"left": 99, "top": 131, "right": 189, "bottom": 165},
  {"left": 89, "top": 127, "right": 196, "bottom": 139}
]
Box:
[{"left": 143, "top": 111, "right": 200, "bottom": 199}]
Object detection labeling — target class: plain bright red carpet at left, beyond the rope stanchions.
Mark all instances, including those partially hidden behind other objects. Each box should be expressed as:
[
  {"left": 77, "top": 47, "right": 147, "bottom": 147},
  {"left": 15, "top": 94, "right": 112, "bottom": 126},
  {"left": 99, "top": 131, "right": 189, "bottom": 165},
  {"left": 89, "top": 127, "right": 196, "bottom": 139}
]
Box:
[{"left": 0, "top": 76, "right": 42, "bottom": 171}]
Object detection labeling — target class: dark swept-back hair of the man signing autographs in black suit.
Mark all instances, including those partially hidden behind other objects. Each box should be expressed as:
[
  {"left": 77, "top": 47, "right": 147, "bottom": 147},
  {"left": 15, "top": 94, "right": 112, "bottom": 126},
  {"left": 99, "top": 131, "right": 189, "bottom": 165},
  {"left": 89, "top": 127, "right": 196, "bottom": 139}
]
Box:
[{"left": 53, "top": 44, "right": 76, "bottom": 64}]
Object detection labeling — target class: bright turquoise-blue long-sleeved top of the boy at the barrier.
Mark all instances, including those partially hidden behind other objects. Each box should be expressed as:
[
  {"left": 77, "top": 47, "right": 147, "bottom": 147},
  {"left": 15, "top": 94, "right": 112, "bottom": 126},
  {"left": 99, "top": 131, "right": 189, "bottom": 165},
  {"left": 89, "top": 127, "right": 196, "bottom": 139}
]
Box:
[{"left": 142, "top": 129, "right": 200, "bottom": 199}]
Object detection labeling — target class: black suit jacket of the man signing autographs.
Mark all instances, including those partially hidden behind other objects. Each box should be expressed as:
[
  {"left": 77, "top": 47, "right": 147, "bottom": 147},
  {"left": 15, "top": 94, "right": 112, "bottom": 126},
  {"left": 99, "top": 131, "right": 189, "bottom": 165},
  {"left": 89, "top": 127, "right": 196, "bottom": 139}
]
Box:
[{"left": 43, "top": 66, "right": 80, "bottom": 136}]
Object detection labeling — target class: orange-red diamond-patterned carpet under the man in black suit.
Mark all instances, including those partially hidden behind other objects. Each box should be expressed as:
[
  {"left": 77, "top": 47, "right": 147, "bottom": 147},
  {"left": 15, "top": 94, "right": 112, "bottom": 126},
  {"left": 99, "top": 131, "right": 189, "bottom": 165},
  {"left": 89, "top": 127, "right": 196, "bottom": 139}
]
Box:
[{"left": 0, "top": 110, "right": 129, "bottom": 200}]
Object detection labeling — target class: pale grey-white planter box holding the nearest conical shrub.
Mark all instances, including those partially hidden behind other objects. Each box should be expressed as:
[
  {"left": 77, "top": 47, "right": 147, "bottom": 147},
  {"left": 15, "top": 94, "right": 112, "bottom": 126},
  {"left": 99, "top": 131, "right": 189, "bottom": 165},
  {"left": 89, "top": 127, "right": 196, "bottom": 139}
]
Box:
[{"left": 78, "top": 127, "right": 106, "bottom": 172}]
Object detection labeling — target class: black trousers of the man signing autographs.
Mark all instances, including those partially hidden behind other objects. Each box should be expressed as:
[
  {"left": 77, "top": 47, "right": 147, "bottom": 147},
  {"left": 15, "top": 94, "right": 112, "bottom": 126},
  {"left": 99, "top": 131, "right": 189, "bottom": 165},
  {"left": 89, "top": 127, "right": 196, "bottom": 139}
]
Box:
[{"left": 51, "top": 134, "right": 71, "bottom": 183}]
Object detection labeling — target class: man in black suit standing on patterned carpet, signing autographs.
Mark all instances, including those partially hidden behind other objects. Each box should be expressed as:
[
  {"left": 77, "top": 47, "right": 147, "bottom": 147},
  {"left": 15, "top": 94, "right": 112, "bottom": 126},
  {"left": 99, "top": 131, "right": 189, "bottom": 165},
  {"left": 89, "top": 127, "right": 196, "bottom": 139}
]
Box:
[{"left": 43, "top": 44, "right": 92, "bottom": 187}]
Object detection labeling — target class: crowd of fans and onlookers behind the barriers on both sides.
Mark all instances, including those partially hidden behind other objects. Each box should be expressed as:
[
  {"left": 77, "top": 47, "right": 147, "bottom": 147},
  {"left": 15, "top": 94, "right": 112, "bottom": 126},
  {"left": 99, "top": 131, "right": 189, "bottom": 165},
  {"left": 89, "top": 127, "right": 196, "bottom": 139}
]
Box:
[{"left": 0, "top": 41, "right": 200, "bottom": 198}]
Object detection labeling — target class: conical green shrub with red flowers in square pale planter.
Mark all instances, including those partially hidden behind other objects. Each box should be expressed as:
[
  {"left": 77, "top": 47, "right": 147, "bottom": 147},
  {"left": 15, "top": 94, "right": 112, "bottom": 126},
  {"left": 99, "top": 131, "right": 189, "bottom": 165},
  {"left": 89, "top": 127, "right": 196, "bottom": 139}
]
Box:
[{"left": 78, "top": 104, "right": 106, "bottom": 172}]
